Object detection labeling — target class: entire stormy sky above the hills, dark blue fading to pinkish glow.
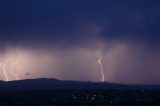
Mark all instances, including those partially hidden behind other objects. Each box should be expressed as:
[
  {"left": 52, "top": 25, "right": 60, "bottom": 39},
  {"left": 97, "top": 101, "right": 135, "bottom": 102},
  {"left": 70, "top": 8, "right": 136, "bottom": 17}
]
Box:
[{"left": 0, "top": 0, "right": 160, "bottom": 84}]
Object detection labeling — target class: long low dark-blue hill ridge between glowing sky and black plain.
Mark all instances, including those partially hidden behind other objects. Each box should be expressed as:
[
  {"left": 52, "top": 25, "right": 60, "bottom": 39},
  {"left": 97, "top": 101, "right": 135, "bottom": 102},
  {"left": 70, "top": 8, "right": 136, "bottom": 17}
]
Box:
[{"left": 0, "top": 78, "right": 160, "bottom": 90}]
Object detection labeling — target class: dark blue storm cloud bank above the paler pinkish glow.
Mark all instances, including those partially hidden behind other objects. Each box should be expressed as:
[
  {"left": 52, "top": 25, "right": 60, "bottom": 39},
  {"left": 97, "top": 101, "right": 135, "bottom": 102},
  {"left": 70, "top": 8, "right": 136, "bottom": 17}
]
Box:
[{"left": 0, "top": 0, "right": 160, "bottom": 44}]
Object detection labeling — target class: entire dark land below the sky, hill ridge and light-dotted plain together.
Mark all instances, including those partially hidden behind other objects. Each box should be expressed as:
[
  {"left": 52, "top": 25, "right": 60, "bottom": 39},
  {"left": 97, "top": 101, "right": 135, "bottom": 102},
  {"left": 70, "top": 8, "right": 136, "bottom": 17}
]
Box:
[{"left": 0, "top": 78, "right": 160, "bottom": 106}]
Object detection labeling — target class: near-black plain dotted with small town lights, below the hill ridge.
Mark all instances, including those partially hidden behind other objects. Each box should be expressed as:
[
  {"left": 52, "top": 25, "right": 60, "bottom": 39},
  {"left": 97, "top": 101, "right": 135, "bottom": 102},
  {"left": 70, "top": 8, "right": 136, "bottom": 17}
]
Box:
[{"left": 0, "top": 89, "right": 160, "bottom": 106}]
